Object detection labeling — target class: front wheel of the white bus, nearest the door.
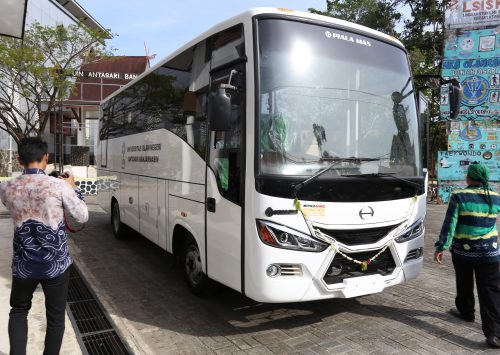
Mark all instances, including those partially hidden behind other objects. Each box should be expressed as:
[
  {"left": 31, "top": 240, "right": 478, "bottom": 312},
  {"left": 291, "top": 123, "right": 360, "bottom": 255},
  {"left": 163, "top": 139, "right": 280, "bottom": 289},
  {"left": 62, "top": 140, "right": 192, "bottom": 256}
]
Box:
[{"left": 183, "top": 237, "right": 216, "bottom": 297}]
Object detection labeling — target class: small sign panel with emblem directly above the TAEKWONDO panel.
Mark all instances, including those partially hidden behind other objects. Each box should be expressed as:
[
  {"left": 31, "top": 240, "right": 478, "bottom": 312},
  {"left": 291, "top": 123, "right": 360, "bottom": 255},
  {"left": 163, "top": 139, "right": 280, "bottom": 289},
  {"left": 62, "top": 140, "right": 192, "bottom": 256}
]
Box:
[{"left": 448, "top": 120, "right": 500, "bottom": 151}]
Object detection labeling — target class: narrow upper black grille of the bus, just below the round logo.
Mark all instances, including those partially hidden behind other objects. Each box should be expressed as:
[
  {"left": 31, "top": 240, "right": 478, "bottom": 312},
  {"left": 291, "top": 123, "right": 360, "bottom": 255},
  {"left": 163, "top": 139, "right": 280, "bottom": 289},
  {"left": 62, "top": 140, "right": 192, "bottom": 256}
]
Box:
[{"left": 316, "top": 224, "right": 398, "bottom": 245}]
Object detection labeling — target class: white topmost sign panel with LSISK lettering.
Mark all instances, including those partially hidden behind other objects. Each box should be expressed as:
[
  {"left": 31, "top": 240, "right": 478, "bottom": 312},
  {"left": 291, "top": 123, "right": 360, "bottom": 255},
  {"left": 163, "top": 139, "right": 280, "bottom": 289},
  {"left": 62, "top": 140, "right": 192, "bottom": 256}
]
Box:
[{"left": 444, "top": 0, "right": 500, "bottom": 29}]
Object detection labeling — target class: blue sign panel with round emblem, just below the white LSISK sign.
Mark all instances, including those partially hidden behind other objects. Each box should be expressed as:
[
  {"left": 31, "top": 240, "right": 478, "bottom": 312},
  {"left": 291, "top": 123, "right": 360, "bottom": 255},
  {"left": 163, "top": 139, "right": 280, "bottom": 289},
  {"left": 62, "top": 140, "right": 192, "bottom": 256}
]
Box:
[{"left": 440, "top": 29, "right": 500, "bottom": 120}]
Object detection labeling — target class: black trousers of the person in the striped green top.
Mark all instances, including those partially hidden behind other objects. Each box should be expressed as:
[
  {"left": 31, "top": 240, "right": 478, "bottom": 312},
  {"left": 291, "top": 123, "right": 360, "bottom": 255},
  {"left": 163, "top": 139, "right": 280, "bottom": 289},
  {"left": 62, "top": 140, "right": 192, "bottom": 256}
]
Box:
[{"left": 452, "top": 256, "right": 500, "bottom": 338}]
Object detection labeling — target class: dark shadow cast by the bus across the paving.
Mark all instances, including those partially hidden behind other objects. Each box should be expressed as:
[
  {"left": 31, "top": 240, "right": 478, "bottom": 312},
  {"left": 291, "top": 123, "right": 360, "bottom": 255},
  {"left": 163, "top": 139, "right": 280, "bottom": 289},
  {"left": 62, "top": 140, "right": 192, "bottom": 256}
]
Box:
[{"left": 68, "top": 212, "right": 484, "bottom": 350}]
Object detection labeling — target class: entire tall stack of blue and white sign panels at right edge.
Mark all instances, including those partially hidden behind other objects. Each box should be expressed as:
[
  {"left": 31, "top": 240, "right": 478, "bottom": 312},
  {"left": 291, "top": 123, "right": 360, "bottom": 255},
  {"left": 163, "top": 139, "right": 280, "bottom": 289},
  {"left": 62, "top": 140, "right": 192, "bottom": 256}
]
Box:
[{"left": 438, "top": 0, "right": 500, "bottom": 203}]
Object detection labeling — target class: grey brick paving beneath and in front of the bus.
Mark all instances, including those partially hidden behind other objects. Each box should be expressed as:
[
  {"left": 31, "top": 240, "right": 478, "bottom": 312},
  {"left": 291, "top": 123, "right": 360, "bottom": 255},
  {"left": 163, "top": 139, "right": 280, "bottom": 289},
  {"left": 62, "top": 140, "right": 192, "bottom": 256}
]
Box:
[{"left": 64, "top": 200, "right": 498, "bottom": 354}]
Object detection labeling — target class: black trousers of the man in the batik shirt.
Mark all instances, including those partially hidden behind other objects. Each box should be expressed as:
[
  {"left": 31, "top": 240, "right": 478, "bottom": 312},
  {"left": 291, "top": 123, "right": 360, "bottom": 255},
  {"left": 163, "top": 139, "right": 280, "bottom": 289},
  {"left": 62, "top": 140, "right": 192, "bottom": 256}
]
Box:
[{"left": 9, "top": 269, "right": 69, "bottom": 355}]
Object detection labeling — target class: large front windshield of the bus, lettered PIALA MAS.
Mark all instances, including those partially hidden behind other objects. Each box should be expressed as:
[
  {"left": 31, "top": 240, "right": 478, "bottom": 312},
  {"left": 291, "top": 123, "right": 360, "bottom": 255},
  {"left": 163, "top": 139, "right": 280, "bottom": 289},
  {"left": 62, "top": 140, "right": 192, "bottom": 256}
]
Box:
[{"left": 257, "top": 19, "right": 422, "bottom": 176}]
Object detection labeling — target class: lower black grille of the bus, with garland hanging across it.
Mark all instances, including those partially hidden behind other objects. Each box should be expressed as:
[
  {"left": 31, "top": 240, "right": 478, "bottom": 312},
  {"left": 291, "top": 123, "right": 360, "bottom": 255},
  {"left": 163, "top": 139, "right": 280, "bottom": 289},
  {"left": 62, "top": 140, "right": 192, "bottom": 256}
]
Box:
[{"left": 323, "top": 248, "right": 396, "bottom": 285}]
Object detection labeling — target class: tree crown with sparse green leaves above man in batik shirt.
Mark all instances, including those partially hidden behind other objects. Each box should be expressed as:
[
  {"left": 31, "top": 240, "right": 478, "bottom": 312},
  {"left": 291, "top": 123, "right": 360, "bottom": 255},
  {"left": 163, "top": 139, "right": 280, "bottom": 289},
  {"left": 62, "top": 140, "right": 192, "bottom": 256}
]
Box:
[{"left": 0, "top": 23, "right": 109, "bottom": 143}]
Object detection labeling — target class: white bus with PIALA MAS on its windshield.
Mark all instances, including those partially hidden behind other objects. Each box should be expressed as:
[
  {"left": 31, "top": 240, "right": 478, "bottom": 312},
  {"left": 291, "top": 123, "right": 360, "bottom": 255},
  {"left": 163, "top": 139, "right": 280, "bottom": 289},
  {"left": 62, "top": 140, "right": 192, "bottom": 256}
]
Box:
[{"left": 98, "top": 8, "right": 460, "bottom": 302}]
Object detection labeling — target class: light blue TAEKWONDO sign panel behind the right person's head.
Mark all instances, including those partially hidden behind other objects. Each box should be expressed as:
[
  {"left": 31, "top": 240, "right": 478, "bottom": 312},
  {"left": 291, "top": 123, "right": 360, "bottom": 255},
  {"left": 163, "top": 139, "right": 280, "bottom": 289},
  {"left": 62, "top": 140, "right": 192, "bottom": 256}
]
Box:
[{"left": 438, "top": 150, "right": 500, "bottom": 181}]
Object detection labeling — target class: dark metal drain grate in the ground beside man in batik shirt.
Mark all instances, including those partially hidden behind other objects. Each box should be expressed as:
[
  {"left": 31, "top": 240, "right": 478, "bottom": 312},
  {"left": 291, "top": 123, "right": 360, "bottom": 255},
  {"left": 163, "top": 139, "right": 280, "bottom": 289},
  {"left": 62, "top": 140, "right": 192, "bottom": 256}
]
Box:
[{"left": 67, "top": 264, "right": 130, "bottom": 355}]
